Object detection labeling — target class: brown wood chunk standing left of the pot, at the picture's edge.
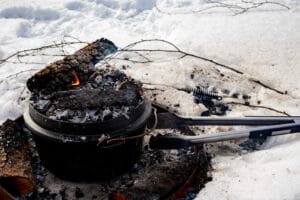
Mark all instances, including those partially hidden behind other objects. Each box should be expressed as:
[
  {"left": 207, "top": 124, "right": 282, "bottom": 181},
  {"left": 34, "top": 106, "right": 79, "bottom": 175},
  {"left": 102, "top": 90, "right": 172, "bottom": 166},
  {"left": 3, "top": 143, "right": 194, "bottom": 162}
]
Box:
[{"left": 0, "top": 119, "right": 35, "bottom": 195}]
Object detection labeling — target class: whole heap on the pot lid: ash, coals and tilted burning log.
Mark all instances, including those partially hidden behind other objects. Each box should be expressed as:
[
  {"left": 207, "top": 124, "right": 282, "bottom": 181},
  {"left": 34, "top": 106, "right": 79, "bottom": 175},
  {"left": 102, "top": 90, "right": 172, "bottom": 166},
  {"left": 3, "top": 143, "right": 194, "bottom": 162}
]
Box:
[{"left": 27, "top": 38, "right": 142, "bottom": 123}]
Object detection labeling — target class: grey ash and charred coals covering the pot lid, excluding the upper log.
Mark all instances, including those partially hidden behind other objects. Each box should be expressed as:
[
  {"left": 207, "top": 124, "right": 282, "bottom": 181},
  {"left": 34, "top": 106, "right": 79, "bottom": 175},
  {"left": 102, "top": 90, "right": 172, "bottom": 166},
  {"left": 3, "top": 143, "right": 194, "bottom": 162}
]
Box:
[{"left": 30, "top": 66, "right": 142, "bottom": 123}]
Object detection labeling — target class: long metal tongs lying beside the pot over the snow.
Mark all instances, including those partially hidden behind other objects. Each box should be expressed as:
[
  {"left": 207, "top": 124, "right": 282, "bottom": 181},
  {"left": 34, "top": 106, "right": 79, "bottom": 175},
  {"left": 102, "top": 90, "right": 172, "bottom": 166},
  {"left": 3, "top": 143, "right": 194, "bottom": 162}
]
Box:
[{"left": 150, "top": 107, "right": 300, "bottom": 149}]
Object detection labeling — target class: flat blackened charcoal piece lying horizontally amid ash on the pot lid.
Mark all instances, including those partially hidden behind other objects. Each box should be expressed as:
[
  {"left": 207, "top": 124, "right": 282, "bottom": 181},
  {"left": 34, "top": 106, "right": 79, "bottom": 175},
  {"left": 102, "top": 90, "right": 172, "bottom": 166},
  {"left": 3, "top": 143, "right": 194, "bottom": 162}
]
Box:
[{"left": 51, "top": 82, "right": 141, "bottom": 110}]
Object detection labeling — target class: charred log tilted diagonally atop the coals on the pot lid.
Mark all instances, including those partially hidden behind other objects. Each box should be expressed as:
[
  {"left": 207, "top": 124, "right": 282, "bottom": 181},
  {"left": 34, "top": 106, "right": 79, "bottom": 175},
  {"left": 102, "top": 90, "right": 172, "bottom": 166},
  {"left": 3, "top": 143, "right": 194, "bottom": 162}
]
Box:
[{"left": 27, "top": 38, "right": 117, "bottom": 93}]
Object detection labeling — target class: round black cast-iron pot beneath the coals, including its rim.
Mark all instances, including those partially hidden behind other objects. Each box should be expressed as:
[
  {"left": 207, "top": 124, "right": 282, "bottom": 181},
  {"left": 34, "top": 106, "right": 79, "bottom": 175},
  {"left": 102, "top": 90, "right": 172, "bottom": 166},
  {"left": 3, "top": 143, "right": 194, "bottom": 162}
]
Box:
[{"left": 24, "top": 99, "right": 152, "bottom": 181}]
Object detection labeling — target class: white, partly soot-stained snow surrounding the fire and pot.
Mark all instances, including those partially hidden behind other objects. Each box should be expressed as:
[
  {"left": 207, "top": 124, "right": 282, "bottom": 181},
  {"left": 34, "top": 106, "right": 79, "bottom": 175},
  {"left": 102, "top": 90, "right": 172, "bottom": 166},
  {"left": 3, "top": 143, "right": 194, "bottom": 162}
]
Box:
[{"left": 0, "top": 0, "right": 300, "bottom": 199}]
